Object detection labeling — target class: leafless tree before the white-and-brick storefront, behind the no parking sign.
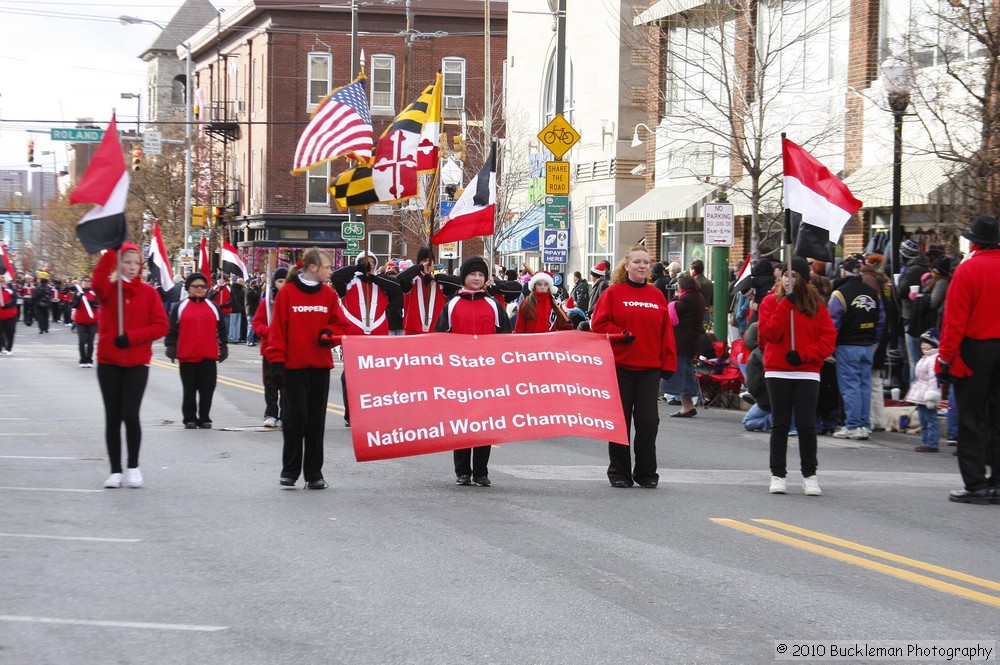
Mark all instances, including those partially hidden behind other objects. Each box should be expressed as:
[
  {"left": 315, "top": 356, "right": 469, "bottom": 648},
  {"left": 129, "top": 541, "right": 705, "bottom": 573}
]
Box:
[{"left": 636, "top": 0, "right": 847, "bottom": 255}]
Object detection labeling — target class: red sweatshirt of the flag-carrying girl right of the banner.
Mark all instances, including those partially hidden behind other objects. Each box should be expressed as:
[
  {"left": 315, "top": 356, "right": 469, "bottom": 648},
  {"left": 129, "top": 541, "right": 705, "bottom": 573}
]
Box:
[{"left": 757, "top": 293, "right": 837, "bottom": 374}]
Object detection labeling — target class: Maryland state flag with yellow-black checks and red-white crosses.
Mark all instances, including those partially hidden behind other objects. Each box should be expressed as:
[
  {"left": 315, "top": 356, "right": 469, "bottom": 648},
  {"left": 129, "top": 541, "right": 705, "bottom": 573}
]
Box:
[{"left": 330, "top": 74, "right": 441, "bottom": 208}]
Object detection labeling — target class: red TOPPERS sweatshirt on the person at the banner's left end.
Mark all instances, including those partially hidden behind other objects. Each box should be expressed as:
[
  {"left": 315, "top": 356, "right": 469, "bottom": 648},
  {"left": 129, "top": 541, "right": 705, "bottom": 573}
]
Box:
[{"left": 258, "top": 277, "right": 349, "bottom": 369}]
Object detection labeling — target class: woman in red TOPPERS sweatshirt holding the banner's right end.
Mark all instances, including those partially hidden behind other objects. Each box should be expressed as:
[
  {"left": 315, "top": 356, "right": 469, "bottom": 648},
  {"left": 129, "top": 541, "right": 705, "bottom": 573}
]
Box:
[{"left": 590, "top": 245, "right": 677, "bottom": 489}]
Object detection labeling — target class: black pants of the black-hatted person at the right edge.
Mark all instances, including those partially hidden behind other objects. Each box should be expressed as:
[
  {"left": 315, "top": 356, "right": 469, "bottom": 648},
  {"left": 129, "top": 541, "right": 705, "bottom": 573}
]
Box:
[{"left": 955, "top": 338, "right": 1000, "bottom": 492}]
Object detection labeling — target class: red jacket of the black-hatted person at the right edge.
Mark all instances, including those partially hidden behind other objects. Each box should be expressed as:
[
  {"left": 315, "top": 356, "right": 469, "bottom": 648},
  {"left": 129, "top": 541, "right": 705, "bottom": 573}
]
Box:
[{"left": 938, "top": 249, "right": 1000, "bottom": 377}]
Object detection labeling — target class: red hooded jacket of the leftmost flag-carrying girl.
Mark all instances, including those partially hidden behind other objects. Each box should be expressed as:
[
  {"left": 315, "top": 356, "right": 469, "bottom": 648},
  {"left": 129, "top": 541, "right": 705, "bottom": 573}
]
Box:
[{"left": 92, "top": 243, "right": 168, "bottom": 367}]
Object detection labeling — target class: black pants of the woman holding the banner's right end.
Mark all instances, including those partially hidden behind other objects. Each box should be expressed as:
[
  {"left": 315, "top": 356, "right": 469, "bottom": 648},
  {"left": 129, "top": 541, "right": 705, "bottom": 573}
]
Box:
[{"left": 608, "top": 367, "right": 660, "bottom": 484}]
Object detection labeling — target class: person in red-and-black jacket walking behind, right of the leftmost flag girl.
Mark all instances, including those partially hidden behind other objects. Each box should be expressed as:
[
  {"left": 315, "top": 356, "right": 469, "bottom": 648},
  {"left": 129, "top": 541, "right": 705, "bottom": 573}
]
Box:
[{"left": 163, "top": 272, "right": 229, "bottom": 429}]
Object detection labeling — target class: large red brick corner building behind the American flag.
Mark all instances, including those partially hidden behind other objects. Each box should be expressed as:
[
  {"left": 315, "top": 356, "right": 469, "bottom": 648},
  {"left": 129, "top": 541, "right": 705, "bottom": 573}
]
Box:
[{"left": 179, "top": 0, "right": 507, "bottom": 269}]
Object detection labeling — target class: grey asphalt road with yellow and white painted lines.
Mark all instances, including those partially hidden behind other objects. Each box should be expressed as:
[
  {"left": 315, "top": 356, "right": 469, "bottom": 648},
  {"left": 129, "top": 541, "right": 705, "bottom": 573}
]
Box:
[{"left": 0, "top": 326, "right": 1000, "bottom": 665}]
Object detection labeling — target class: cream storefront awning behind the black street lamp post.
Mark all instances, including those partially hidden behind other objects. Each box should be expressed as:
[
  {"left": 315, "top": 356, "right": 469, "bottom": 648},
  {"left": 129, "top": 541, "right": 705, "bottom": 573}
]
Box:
[{"left": 844, "top": 159, "right": 955, "bottom": 208}]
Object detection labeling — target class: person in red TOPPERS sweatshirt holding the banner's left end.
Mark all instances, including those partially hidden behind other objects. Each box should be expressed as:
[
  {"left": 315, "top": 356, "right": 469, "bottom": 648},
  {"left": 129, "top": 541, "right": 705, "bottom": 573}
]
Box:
[{"left": 265, "top": 247, "right": 348, "bottom": 490}]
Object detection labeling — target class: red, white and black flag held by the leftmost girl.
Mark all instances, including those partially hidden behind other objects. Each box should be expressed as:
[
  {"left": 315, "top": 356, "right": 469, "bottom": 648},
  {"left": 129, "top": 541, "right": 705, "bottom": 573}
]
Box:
[{"left": 69, "top": 115, "right": 129, "bottom": 254}]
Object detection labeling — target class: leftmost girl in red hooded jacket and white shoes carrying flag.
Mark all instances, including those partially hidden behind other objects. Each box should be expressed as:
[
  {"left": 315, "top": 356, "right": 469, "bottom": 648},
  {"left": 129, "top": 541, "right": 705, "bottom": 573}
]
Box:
[{"left": 92, "top": 242, "right": 167, "bottom": 488}]
